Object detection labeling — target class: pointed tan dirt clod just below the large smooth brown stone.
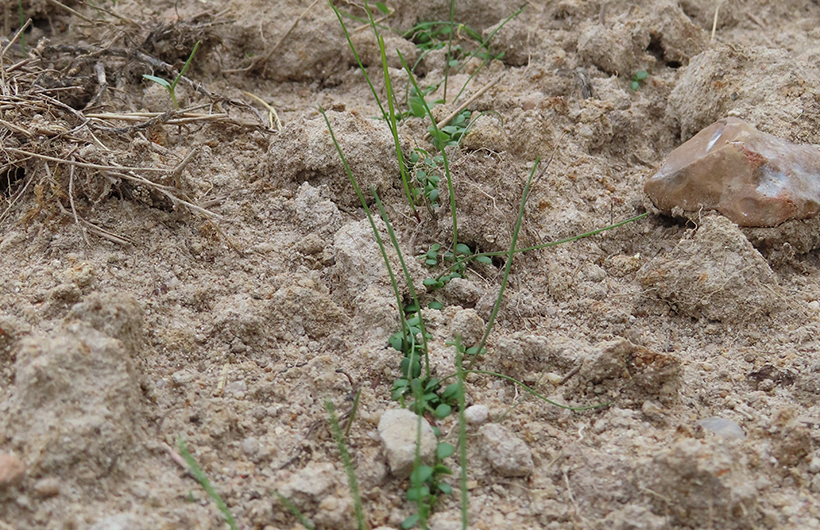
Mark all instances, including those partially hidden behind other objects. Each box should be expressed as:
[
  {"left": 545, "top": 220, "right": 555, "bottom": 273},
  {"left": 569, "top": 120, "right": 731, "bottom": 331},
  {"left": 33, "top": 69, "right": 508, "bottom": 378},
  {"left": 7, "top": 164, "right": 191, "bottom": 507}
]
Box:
[{"left": 638, "top": 215, "right": 780, "bottom": 323}]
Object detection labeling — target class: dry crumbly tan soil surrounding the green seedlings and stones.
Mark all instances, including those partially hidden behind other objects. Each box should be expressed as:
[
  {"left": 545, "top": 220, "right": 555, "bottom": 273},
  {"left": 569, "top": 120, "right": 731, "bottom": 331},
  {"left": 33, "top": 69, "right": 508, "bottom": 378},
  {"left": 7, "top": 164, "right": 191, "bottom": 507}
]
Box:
[{"left": 0, "top": 0, "right": 820, "bottom": 530}]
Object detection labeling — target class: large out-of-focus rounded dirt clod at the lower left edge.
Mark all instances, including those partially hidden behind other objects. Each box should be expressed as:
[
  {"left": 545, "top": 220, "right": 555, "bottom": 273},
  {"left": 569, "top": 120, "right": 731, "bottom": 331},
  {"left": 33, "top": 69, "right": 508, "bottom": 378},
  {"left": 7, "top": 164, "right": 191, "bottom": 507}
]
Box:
[{"left": 0, "top": 321, "right": 142, "bottom": 483}]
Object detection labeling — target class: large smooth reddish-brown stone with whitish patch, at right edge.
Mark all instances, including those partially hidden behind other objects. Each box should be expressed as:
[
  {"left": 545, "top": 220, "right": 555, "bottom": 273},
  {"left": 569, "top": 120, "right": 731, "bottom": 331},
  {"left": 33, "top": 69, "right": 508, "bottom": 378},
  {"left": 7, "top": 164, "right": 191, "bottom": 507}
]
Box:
[{"left": 644, "top": 118, "right": 820, "bottom": 227}]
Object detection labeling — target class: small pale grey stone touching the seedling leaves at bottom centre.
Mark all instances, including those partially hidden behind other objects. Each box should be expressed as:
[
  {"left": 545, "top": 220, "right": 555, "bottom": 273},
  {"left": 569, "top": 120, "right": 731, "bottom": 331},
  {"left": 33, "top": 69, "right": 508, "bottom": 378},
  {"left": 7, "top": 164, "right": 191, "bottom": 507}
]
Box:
[{"left": 378, "top": 409, "right": 436, "bottom": 478}]
